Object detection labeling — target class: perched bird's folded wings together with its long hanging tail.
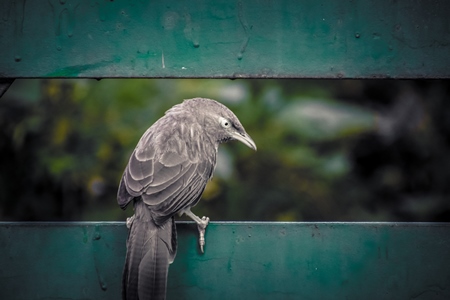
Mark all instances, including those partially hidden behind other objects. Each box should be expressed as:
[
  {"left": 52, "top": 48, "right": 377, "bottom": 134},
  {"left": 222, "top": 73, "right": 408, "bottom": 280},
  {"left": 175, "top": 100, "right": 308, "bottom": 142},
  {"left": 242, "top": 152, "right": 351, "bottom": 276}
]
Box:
[{"left": 118, "top": 123, "right": 215, "bottom": 299}]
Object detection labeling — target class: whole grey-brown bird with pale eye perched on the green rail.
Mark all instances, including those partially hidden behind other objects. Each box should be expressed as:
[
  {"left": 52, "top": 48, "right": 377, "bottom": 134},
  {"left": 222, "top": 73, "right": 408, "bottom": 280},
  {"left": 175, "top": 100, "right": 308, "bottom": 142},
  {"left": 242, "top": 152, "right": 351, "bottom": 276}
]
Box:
[{"left": 117, "top": 98, "right": 257, "bottom": 300}]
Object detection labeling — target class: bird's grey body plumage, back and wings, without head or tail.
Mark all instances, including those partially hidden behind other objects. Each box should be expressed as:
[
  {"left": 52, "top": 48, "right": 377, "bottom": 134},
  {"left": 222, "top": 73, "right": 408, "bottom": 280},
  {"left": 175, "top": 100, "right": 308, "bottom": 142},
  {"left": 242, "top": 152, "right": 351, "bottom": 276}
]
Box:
[{"left": 118, "top": 101, "right": 217, "bottom": 224}]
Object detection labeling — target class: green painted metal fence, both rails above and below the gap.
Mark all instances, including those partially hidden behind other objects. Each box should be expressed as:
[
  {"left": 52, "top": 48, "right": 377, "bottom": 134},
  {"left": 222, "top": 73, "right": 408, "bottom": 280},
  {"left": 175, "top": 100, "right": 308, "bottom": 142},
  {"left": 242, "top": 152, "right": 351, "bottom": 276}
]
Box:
[{"left": 0, "top": 0, "right": 450, "bottom": 300}]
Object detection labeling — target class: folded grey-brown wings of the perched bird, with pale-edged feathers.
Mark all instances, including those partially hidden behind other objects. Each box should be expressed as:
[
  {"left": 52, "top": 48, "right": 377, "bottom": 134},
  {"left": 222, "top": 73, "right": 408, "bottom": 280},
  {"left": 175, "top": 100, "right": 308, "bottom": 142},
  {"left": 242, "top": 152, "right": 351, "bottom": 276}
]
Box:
[{"left": 118, "top": 122, "right": 215, "bottom": 223}]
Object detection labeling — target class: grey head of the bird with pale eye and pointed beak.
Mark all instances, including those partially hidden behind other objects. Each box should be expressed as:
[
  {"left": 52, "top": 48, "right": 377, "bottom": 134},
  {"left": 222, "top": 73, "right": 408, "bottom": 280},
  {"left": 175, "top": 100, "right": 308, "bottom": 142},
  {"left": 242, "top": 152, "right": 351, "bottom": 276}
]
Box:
[{"left": 174, "top": 98, "right": 256, "bottom": 151}]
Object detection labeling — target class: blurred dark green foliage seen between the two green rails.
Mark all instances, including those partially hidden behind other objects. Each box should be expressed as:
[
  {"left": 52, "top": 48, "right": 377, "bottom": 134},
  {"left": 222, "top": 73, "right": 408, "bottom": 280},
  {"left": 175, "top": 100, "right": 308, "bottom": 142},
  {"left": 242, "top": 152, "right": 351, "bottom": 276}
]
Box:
[{"left": 0, "top": 79, "right": 450, "bottom": 221}]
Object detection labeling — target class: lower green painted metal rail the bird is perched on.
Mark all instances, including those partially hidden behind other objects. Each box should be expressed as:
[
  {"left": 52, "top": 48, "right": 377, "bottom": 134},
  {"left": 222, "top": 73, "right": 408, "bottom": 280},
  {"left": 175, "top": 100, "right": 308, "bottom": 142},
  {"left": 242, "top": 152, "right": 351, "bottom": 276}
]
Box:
[{"left": 0, "top": 222, "right": 450, "bottom": 300}]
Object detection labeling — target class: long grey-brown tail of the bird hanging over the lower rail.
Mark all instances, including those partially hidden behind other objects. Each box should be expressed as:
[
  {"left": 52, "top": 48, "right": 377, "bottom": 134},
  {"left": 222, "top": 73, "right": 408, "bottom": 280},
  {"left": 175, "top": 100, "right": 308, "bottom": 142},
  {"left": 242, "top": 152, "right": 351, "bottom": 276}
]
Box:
[{"left": 122, "top": 199, "right": 177, "bottom": 300}]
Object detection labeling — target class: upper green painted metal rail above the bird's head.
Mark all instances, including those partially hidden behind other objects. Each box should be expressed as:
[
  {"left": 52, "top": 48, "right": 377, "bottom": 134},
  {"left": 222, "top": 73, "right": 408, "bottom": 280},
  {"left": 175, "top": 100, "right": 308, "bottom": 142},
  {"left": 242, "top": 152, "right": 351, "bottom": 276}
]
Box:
[{"left": 0, "top": 0, "right": 450, "bottom": 78}]
